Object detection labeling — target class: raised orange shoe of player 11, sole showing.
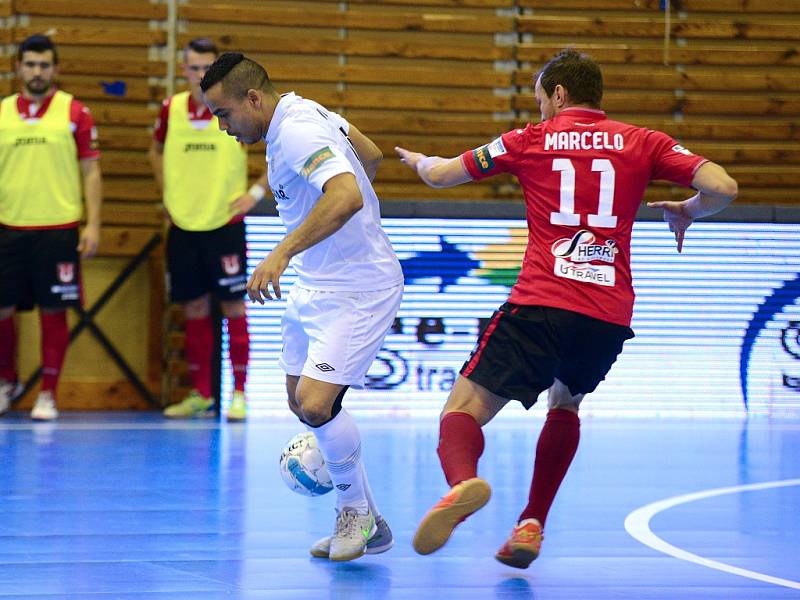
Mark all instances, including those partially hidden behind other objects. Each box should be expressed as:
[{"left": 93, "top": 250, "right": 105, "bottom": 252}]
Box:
[{"left": 413, "top": 477, "right": 492, "bottom": 554}]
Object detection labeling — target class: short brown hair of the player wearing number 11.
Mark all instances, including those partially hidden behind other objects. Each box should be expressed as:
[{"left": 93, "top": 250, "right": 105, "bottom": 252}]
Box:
[{"left": 539, "top": 48, "right": 603, "bottom": 108}]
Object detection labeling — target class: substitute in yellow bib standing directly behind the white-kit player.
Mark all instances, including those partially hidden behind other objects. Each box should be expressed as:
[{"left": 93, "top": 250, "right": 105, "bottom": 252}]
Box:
[{"left": 150, "top": 38, "right": 267, "bottom": 421}]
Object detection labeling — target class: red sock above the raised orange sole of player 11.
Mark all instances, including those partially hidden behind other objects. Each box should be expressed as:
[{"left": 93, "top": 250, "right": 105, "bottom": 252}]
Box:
[{"left": 436, "top": 412, "right": 483, "bottom": 487}]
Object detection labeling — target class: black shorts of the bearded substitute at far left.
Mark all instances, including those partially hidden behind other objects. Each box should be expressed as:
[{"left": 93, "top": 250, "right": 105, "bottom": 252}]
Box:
[{"left": 0, "top": 226, "right": 81, "bottom": 310}]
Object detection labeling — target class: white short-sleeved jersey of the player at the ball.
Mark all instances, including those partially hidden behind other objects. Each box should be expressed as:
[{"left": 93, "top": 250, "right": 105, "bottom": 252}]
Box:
[{"left": 264, "top": 93, "right": 403, "bottom": 292}]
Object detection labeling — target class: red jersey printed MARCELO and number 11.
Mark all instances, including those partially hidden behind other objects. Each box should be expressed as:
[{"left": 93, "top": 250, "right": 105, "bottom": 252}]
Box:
[{"left": 461, "top": 108, "right": 706, "bottom": 326}]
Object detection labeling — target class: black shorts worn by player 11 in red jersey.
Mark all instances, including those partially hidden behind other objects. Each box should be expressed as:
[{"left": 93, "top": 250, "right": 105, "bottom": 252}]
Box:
[{"left": 461, "top": 302, "right": 633, "bottom": 408}]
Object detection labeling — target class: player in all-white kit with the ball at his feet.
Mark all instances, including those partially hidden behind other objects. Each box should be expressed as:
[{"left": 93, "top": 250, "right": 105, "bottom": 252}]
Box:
[{"left": 200, "top": 53, "right": 403, "bottom": 561}]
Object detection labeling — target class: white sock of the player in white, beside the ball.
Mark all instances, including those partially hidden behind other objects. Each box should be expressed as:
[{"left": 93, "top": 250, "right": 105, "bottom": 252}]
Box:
[{"left": 308, "top": 409, "right": 369, "bottom": 514}]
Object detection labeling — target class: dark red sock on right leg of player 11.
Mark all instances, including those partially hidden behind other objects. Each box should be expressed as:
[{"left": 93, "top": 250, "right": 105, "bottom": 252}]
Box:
[{"left": 519, "top": 408, "right": 581, "bottom": 527}]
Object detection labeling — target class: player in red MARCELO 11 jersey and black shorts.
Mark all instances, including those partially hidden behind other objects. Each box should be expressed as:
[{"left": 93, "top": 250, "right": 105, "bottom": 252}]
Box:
[{"left": 396, "top": 50, "right": 737, "bottom": 568}]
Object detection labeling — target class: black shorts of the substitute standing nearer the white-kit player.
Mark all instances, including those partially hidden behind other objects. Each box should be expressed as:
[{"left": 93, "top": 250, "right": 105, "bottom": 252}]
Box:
[{"left": 167, "top": 221, "right": 247, "bottom": 302}]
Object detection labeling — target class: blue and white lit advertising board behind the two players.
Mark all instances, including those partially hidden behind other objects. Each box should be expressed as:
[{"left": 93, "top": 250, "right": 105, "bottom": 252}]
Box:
[{"left": 223, "top": 217, "right": 800, "bottom": 416}]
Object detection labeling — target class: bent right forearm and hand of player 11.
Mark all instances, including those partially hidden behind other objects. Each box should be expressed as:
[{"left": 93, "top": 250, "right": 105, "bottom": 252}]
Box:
[{"left": 647, "top": 162, "right": 739, "bottom": 252}]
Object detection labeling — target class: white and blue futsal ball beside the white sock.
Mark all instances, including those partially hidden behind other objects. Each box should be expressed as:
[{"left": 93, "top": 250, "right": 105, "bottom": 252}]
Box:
[{"left": 280, "top": 431, "right": 333, "bottom": 496}]
